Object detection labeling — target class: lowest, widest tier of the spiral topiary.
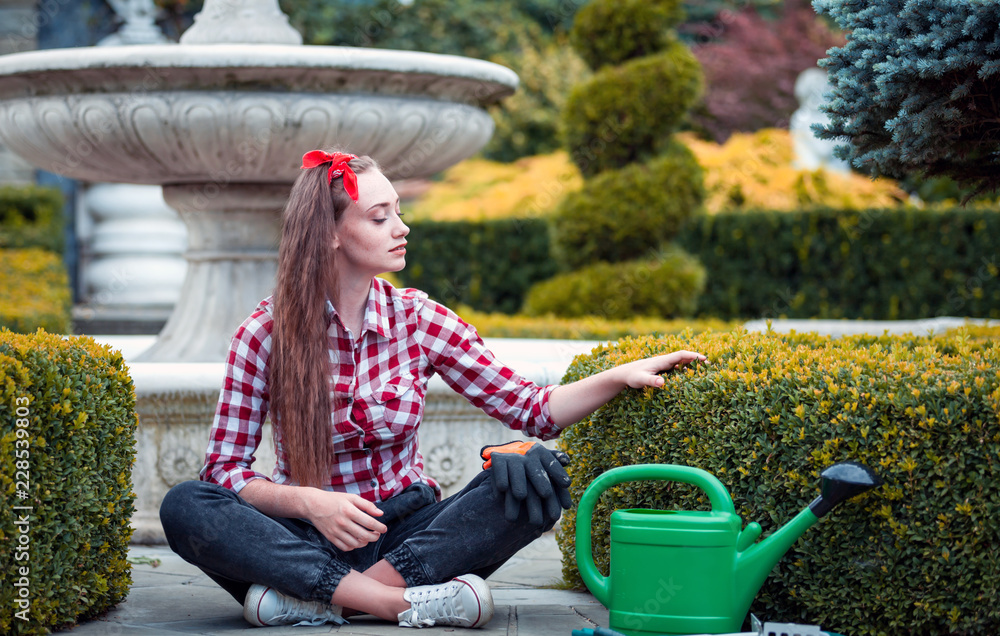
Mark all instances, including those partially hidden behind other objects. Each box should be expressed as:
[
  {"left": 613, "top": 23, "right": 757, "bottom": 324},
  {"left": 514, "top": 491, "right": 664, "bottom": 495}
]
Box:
[{"left": 523, "top": 247, "right": 705, "bottom": 319}]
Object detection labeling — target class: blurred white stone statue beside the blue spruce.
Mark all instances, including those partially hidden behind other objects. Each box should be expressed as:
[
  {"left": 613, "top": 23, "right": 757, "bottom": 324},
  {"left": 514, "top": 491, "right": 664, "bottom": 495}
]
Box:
[{"left": 789, "top": 68, "right": 850, "bottom": 172}]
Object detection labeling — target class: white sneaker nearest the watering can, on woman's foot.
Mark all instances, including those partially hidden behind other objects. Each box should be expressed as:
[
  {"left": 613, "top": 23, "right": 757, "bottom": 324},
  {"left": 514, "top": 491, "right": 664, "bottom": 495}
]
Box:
[{"left": 399, "top": 574, "right": 493, "bottom": 627}]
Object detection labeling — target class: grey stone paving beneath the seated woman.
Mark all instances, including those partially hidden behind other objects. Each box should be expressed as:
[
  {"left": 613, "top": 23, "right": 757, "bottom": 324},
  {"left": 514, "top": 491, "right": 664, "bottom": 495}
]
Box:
[{"left": 63, "top": 533, "right": 608, "bottom": 636}]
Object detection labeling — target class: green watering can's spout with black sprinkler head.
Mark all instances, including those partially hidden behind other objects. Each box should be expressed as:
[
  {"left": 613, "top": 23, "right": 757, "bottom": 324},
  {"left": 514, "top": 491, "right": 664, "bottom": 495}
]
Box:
[{"left": 736, "top": 462, "right": 882, "bottom": 611}]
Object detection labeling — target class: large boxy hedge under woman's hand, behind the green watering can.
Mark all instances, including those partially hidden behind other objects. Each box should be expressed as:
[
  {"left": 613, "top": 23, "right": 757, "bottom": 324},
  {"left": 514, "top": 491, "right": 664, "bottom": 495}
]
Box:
[{"left": 557, "top": 330, "right": 1000, "bottom": 636}]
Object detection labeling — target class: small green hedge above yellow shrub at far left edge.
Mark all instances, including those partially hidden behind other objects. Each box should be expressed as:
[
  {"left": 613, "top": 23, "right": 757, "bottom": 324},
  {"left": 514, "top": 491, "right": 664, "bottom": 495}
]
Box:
[{"left": 0, "top": 185, "right": 65, "bottom": 254}]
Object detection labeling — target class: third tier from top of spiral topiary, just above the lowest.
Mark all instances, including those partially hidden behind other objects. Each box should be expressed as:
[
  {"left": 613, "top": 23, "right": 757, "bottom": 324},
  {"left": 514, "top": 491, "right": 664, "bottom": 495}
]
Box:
[{"left": 552, "top": 140, "right": 705, "bottom": 268}]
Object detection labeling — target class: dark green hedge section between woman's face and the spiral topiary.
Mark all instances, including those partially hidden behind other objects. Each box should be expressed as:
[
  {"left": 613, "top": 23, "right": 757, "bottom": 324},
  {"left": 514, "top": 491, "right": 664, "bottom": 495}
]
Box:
[{"left": 396, "top": 219, "right": 558, "bottom": 313}]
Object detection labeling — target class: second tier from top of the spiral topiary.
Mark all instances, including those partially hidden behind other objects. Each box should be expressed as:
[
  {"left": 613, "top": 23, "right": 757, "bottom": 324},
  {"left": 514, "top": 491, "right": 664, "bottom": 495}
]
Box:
[{"left": 563, "top": 42, "right": 704, "bottom": 176}]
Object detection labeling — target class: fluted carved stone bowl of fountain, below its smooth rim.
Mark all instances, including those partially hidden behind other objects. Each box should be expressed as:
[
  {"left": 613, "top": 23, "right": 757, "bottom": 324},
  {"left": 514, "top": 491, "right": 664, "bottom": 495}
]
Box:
[{"left": 0, "top": 91, "right": 493, "bottom": 185}]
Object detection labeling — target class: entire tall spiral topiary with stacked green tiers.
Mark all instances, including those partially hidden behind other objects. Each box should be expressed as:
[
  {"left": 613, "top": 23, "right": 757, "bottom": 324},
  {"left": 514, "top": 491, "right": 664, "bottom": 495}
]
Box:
[{"left": 525, "top": 0, "right": 705, "bottom": 318}]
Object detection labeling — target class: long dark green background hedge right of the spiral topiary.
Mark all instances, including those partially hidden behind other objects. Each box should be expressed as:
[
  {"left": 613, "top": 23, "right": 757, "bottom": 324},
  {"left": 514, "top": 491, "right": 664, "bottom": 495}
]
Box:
[{"left": 677, "top": 208, "right": 1000, "bottom": 320}]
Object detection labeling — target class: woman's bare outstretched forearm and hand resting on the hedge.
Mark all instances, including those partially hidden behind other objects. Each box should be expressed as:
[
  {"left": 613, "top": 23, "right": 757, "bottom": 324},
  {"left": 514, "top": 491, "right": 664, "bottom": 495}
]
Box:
[{"left": 549, "top": 351, "right": 707, "bottom": 428}]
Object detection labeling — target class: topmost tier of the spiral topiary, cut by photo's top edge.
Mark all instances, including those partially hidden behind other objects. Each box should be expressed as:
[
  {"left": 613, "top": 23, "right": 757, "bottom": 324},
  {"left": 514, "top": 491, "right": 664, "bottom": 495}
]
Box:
[{"left": 570, "top": 0, "right": 684, "bottom": 70}]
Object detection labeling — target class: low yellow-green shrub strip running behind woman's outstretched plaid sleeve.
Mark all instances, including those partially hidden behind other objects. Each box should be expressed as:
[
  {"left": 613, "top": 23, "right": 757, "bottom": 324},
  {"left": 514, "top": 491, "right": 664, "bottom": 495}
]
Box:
[{"left": 455, "top": 306, "right": 741, "bottom": 340}]
